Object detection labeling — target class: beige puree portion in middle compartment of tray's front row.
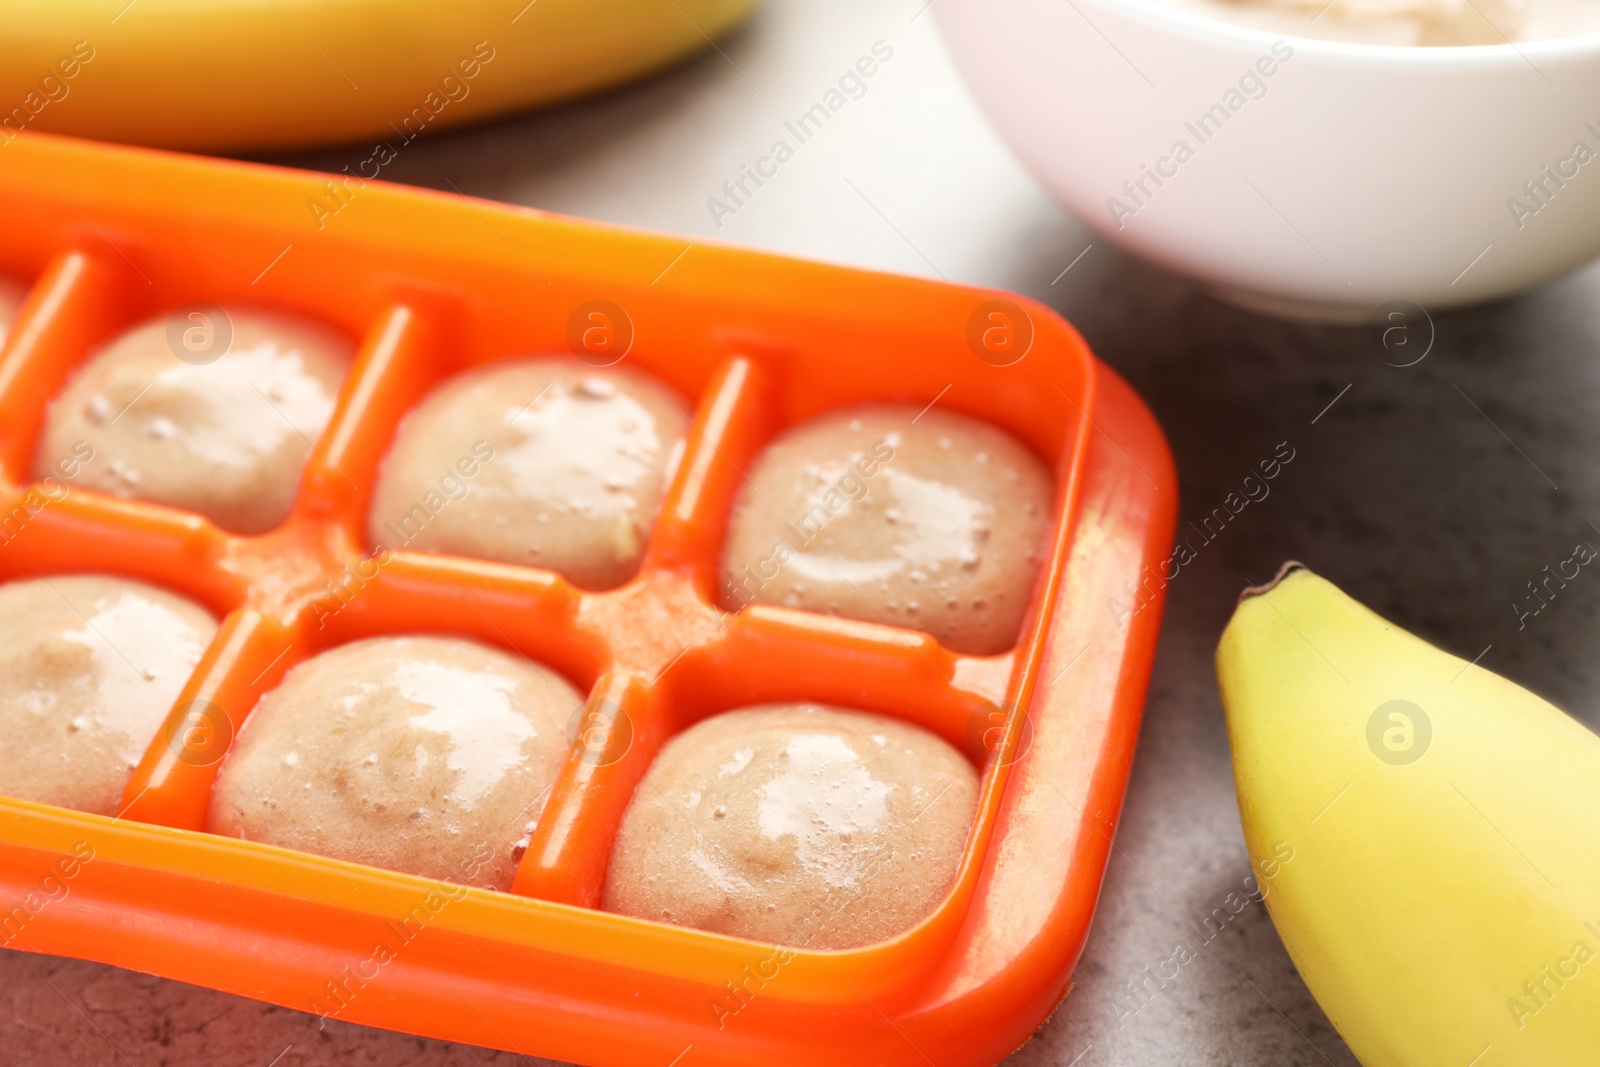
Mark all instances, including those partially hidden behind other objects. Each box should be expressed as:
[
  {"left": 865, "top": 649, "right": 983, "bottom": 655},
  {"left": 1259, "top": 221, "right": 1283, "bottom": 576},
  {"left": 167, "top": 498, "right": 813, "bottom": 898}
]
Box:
[{"left": 208, "top": 637, "right": 582, "bottom": 889}]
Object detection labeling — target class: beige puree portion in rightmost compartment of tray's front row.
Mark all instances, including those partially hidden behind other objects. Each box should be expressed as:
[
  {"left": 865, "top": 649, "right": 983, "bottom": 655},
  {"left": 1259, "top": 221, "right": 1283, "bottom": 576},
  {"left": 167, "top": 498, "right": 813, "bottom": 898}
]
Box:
[{"left": 603, "top": 704, "right": 978, "bottom": 949}]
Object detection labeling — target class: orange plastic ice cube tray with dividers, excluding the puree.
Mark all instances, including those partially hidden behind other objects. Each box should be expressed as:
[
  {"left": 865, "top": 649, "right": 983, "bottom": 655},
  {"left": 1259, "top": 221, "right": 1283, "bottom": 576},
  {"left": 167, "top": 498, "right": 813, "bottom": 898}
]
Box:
[{"left": 0, "top": 133, "right": 1176, "bottom": 1067}]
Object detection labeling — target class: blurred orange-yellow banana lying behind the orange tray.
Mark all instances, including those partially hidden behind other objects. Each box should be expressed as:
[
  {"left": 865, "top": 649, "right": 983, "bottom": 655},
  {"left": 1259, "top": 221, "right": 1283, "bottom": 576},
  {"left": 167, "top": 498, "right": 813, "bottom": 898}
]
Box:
[{"left": 0, "top": 0, "right": 754, "bottom": 151}]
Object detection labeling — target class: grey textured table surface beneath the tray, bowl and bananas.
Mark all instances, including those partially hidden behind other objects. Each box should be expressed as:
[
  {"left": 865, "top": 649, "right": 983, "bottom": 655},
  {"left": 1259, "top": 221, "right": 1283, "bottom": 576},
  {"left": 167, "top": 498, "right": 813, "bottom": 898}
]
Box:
[{"left": 12, "top": 0, "right": 1600, "bottom": 1067}]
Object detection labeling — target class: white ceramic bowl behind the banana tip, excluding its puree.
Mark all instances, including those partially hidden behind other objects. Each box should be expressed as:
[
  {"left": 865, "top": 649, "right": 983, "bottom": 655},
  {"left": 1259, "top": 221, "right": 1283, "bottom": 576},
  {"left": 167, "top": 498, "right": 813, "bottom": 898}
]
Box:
[{"left": 936, "top": 0, "right": 1600, "bottom": 320}]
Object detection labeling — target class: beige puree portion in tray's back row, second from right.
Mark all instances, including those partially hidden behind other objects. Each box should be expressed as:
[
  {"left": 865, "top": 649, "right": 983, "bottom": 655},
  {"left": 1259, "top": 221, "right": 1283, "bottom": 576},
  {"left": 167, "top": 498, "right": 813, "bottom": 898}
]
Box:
[{"left": 368, "top": 360, "right": 688, "bottom": 589}]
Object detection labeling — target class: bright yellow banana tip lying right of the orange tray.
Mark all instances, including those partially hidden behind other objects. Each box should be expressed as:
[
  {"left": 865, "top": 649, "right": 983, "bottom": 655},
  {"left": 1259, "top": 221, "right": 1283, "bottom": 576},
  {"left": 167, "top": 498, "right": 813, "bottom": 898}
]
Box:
[{"left": 1216, "top": 565, "right": 1600, "bottom": 1067}]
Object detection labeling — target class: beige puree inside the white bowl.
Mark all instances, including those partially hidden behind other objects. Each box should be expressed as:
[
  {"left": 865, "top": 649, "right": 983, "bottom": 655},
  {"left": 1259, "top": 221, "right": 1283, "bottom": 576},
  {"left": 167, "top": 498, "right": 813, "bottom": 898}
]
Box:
[{"left": 1165, "top": 0, "right": 1600, "bottom": 45}]
